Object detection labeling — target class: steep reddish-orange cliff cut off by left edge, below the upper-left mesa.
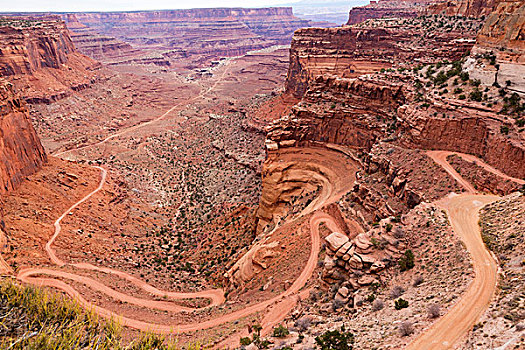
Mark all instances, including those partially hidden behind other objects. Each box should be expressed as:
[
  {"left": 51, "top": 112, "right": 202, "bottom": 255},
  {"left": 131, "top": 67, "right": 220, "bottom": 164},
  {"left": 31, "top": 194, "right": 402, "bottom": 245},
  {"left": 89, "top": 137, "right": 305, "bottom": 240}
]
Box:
[{"left": 0, "top": 78, "right": 47, "bottom": 194}]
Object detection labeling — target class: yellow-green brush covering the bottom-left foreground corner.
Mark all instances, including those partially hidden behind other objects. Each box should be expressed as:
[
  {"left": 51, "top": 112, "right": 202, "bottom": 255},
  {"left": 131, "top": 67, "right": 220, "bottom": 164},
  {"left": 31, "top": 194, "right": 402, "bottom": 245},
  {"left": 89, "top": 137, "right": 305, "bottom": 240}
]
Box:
[{"left": 0, "top": 279, "right": 185, "bottom": 350}]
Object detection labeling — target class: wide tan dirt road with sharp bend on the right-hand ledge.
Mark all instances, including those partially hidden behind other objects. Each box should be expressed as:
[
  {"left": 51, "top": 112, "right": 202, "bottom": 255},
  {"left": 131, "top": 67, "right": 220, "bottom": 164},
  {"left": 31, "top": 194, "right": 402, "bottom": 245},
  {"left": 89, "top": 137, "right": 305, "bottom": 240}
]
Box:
[{"left": 406, "top": 151, "right": 525, "bottom": 350}]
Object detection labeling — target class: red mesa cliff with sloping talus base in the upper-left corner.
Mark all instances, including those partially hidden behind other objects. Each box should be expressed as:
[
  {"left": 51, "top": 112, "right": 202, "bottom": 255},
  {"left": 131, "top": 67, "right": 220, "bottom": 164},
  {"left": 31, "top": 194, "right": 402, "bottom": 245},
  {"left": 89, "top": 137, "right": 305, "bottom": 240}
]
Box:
[{"left": 0, "top": 17, "right": 97, "bottom": 103}]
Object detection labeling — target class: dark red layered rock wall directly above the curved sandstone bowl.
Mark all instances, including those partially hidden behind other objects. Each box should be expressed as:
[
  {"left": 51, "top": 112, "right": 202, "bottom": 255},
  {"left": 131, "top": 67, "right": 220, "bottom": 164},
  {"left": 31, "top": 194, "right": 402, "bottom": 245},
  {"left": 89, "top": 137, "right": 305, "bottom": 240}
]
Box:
[{"left": 267, "top": 76, "right": 405, "bottom": 150}]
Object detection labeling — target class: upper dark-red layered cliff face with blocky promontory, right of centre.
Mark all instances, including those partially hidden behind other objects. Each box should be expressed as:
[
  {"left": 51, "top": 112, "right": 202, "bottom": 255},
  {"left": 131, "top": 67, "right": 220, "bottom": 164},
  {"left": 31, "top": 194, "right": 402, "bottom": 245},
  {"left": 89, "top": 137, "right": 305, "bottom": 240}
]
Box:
[{"left": 286, "top": 18, "right": 479, "bottom": 97}]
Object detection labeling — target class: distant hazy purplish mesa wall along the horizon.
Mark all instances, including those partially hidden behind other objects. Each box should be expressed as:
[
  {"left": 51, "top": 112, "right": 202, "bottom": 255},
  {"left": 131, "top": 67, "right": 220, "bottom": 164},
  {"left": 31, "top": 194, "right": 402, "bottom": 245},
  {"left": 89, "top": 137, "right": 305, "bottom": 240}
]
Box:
[{"left": 67, "top": 8, "right": 310, "bottom": 61}]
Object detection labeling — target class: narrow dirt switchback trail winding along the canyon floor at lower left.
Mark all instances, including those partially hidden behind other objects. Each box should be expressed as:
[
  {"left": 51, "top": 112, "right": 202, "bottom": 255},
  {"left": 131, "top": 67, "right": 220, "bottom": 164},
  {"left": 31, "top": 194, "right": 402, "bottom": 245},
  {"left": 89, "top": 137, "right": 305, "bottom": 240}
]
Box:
[{"left": 17, "top": 167, "right": 348, "bottom": 333}]
